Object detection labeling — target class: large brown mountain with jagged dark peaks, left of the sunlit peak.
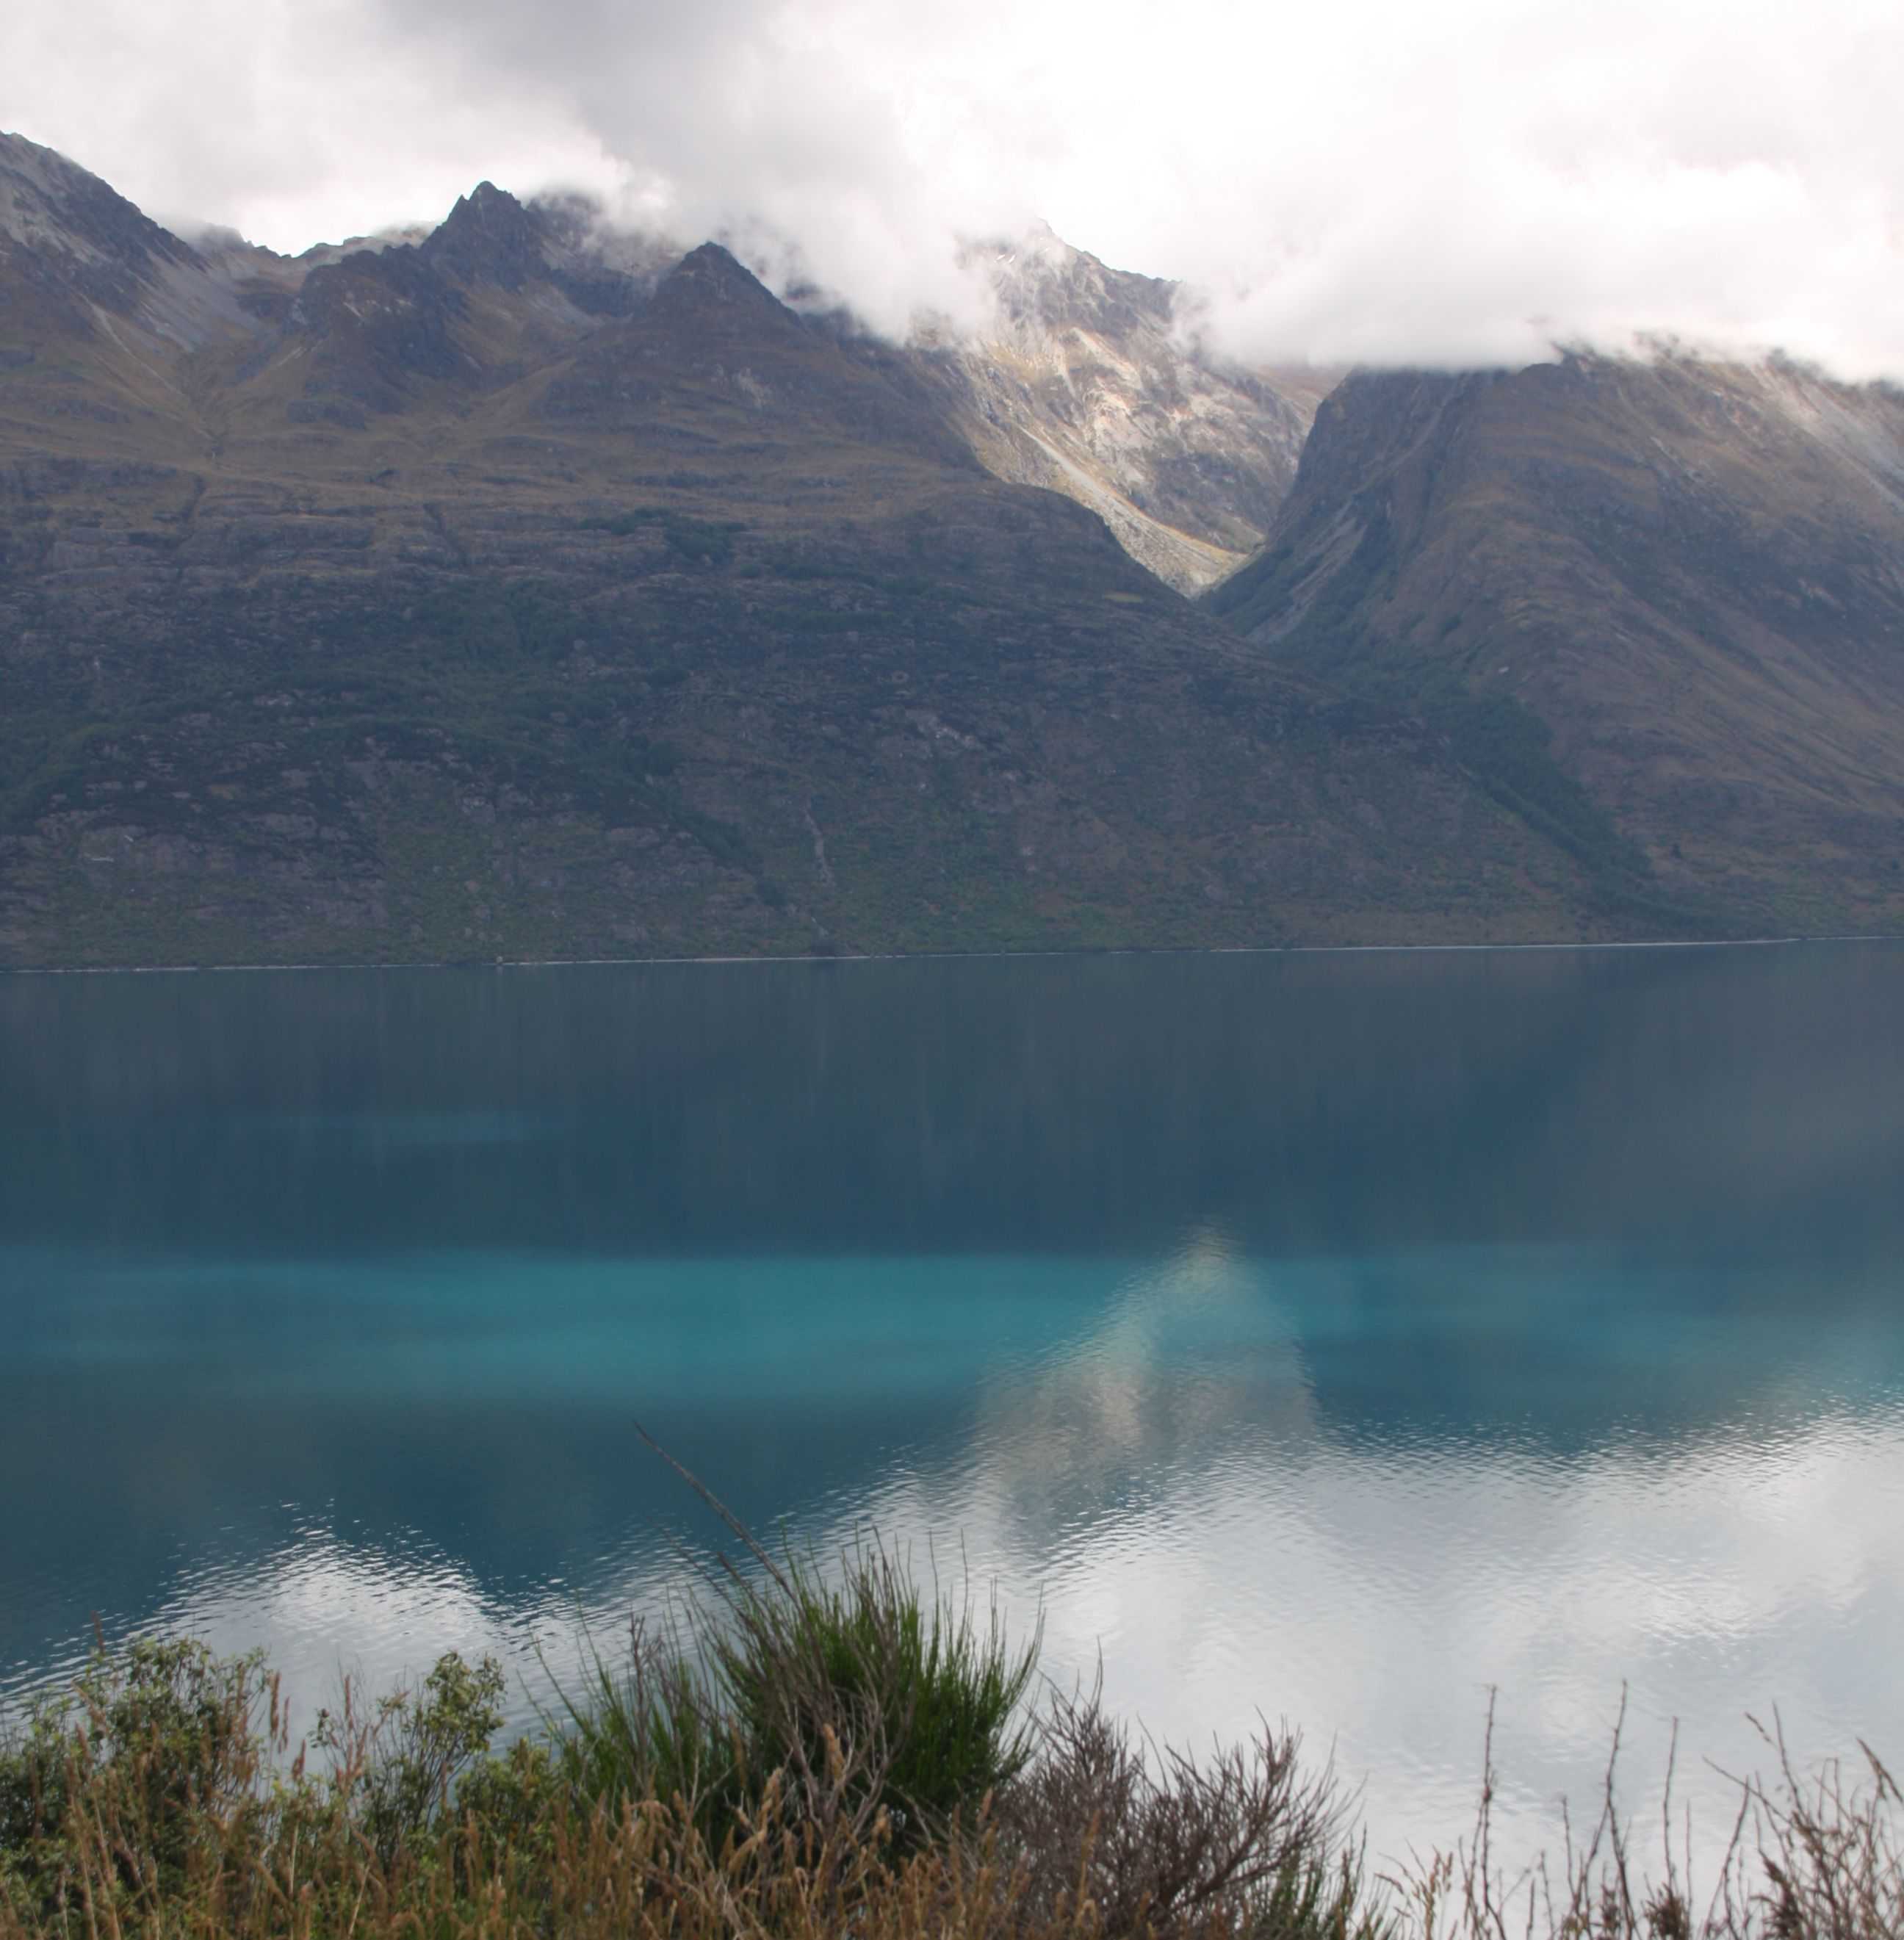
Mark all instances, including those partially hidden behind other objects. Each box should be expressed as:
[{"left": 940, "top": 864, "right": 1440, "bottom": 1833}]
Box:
[{"left": 0, "top": 138, "right": 1615, "bottom": 966}]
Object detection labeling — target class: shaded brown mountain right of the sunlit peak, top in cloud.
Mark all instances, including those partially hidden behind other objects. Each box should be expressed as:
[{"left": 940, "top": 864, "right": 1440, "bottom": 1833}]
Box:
[{"left": 1207, "top": 355, "right": 1904, "bottom": 931}]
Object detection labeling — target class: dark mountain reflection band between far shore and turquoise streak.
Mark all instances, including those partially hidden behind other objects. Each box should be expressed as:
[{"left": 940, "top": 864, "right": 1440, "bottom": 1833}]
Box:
[{"left": 0, "top": 945, "right": 1904, "bottom": 1259}]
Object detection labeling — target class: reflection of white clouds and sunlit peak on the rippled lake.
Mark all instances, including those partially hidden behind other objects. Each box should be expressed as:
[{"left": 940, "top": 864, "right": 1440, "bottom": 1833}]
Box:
[{"left": 81, "top": 1234, "right": 1904, "bottom": 1886}]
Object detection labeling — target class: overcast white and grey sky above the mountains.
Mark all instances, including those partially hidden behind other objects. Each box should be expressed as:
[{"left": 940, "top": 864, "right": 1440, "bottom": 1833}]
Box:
[{"left": 0, "top": 0, "right": 1904, "bottom": 376}]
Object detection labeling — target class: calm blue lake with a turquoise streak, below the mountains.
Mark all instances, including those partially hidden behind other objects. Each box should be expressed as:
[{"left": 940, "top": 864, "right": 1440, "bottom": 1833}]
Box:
[{"left": 0, "top": 945, "right": 1904, "bottom": 1851}]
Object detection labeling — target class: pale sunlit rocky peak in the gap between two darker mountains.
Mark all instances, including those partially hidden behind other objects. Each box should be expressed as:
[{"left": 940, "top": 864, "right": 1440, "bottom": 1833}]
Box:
[{"left": 912, "top": 233, "right": 1339, "bottom": 592}]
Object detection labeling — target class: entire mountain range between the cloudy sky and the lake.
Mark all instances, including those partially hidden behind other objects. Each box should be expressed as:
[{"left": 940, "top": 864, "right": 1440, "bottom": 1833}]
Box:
[{"left": 0, "top": 136, "right": 1904, "bottom": 968}]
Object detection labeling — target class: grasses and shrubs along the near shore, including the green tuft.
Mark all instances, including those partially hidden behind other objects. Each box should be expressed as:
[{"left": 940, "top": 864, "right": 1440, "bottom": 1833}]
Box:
[{"left": 0, "top": 1546, "right": 1904, "bottom": 1940}]
